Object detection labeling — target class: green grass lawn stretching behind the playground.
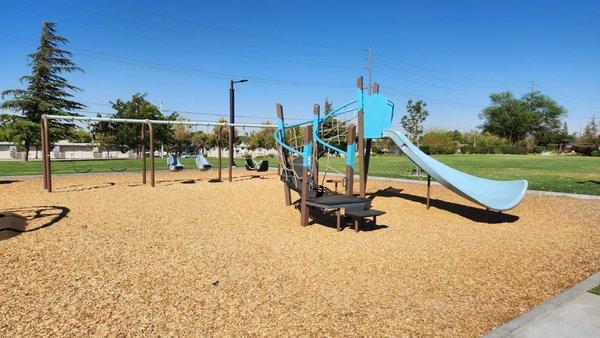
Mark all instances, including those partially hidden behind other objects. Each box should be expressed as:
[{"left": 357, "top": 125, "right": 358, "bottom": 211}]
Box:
[{"left": 0, "top": 154, "right": 600, "bottom": 195}]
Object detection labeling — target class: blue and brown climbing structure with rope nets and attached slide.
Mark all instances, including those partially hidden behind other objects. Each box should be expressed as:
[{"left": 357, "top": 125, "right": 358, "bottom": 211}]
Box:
[{"left": 274, "top": 77, "right": 527, "bottom": 231}]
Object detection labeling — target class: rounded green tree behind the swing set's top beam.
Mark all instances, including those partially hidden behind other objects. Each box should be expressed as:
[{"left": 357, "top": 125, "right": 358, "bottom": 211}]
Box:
[{"left": 91, "top": 93, "right": 179, "bottom": 153}]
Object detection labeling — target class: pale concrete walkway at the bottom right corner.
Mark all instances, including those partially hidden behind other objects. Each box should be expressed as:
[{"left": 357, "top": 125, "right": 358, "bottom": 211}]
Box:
[{"left": 484, "top": 272, "right": 600, "bottom": 338}]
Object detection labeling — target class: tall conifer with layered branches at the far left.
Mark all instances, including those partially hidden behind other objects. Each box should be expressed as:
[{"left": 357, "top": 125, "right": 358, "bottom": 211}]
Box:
[{"left": 0, "top": 22, "right": 85, "bottom": 161}]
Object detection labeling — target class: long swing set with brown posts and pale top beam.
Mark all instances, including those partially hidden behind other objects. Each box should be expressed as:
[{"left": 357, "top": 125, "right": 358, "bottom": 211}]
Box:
[{"left": 40, "top": 115, "right": 275, "bottom": 192}]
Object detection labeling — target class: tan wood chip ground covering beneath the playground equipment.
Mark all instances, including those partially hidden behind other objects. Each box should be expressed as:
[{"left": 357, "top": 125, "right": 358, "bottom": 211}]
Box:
[{"left": 0, "top": 170, "right": 600, "bottom": 336}]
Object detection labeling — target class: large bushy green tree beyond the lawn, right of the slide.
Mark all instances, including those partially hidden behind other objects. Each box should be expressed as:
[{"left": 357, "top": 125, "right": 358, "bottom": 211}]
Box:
[{"left": 479, "top": 92, "right": 566, "bottom": 145}]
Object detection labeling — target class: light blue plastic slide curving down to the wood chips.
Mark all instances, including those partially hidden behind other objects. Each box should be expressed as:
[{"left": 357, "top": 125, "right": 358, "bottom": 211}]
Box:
[{"left": 382, "top": 129, "right": 527, "bottom": 211}]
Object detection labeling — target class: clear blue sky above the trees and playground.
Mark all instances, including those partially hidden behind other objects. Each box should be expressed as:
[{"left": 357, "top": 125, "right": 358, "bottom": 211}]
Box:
[{"left": 0, "top": 0, "right": 600, "bottom": 131}]
